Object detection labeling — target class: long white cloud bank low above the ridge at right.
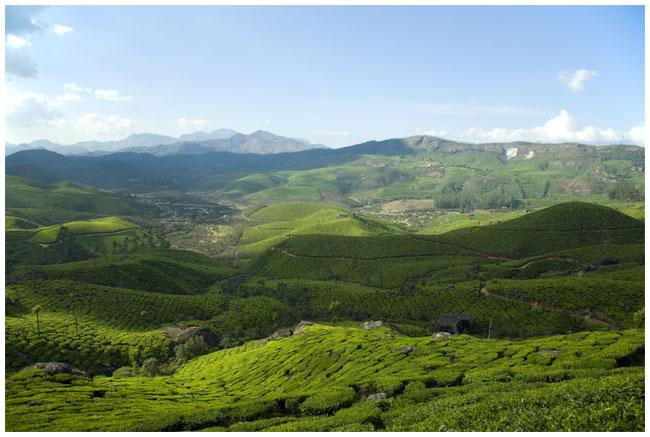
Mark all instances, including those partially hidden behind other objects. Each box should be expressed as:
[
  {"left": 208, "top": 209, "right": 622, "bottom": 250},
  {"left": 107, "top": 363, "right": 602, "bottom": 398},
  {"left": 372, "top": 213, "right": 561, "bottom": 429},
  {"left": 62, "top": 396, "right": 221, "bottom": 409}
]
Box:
[{"left": 436, "top": 109, "right": 645, "bottom": 145}]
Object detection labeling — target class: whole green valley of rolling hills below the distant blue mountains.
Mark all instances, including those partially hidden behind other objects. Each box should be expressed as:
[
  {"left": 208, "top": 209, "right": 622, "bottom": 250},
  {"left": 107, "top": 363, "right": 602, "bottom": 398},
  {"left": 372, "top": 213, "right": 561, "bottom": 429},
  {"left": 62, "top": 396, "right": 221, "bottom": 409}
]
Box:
[{"left": 5, "top": 133, "right": 645, "bottom": 431}]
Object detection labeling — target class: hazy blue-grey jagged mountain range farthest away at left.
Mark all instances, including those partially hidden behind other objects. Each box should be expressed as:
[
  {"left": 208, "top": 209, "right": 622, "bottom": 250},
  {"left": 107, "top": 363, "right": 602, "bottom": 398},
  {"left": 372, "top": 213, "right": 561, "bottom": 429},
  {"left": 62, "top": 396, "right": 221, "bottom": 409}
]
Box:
[{"left": 5, "top": 129, "right": 326, "bottom": 156}]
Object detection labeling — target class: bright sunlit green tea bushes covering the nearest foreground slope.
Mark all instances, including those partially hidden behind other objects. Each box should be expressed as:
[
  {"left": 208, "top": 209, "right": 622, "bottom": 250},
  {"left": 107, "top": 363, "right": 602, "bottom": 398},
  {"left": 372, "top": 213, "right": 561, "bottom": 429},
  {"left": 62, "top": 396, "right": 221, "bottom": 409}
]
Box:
[{"left": 6, "top": 325, "right": 644, "bottom": 431}]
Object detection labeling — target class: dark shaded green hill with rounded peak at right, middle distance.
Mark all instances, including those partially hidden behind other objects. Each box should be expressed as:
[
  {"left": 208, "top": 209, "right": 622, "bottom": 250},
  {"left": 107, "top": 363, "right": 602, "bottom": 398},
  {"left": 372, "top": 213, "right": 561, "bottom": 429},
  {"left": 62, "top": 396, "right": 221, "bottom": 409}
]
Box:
[{"left": 253, "top": 203, "right": 644, "bottom": 287}]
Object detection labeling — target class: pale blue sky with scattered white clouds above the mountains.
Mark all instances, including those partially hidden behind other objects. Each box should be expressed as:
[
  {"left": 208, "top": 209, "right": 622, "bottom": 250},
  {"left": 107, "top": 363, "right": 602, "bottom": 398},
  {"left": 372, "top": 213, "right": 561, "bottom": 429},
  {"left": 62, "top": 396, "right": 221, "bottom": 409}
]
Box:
[{"left": 4, "top": 6, "right": 645, "bottom": 147}]
